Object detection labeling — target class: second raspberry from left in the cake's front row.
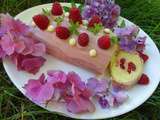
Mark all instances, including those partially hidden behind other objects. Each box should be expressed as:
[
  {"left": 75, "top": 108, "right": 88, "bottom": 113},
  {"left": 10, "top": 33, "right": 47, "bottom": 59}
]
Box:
[{"left": 56, "top": 26, "right": 70, "bottom": 40}]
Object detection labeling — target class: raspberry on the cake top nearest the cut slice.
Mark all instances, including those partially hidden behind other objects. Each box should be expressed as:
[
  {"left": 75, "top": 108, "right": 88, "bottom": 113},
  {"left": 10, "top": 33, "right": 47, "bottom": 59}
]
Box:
[{"left": 98, "top": 35, "right": 111, "bottom": 49}]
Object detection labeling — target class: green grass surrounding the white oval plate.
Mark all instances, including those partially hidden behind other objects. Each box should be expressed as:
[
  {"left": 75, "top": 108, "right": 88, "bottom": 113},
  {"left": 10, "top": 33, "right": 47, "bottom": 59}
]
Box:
[{"left": 0, "top": 0, "right": 160, "bottom": 120}]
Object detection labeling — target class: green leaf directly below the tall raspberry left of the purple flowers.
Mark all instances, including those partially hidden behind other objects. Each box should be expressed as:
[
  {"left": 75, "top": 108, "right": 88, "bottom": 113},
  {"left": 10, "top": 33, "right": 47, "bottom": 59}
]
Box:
[{"left": 69, "top": 22, "right": 80, "bottom": 35}]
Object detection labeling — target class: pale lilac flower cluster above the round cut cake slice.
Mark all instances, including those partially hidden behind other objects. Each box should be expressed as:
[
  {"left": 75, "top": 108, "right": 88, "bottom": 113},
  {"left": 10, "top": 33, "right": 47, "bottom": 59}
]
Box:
[{"left": 114, "top": 26, "right": 146, "bottom": 52}]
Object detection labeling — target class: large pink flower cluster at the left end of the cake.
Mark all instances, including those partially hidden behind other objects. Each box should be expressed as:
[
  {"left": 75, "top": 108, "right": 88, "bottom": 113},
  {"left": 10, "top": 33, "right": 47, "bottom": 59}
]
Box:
[{"left": 0, "top": 14, "right": 46, "bottom": 74}]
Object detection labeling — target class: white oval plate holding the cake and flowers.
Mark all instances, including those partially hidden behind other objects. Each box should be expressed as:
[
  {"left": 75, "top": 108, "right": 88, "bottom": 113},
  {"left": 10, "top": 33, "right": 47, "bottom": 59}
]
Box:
[{"left": 3, "top": 4, "right": 160, "bottom": 119}]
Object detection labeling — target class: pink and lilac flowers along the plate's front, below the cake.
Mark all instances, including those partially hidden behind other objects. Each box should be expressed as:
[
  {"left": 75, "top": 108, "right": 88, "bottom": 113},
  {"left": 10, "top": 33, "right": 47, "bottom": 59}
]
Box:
[{"left": 24, "top": 70, "right": 127, "bottom": 113}]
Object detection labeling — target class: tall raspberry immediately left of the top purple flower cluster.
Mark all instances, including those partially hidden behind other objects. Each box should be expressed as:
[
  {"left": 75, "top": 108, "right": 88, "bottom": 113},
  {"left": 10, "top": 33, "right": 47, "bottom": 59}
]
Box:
[{"left": 69, "top": 7, "right": 82, "bottom": 24}]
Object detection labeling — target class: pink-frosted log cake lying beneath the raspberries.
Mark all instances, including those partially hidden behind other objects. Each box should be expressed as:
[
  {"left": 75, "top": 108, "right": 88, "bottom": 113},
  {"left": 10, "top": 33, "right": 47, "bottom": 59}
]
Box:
[{"left": 34, "top": 25, "right": 117, "bottom": 74}]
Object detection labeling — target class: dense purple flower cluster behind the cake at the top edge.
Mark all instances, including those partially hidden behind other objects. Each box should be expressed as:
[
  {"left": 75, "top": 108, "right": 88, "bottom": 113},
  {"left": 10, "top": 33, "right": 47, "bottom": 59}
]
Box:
[{"left": 82, "top": 0, "right": 120, "bottom": 28}]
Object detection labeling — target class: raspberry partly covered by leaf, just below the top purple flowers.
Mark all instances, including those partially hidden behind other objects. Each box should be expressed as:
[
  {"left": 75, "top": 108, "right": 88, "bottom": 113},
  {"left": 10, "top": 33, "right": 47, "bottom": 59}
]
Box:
[{"left": 88, "top": 15, "right": 101, "bottom": 27}]
